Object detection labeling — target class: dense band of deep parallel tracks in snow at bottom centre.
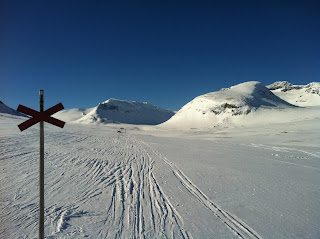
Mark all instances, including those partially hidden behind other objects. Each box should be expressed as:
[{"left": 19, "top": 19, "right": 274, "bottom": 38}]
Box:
[{"left": 99, "top": 136, "right": 192, "bottom": 238}]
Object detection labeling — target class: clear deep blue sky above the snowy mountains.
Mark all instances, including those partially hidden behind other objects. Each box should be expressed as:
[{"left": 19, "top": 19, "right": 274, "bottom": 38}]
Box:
[{"left": 0, "top": 0, "right": 320, "bottom": 110}]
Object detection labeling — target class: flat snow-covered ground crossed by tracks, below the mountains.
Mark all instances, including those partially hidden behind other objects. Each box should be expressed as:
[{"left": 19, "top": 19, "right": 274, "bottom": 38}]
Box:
[{"left": 0, "top": 107, "right": 320, "bottom": 239}]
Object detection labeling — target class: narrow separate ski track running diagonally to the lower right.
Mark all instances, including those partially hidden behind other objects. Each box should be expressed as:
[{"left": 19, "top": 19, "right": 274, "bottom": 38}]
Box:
[{"left": 143, "top": 142, "right": 262, "bottom": 239}]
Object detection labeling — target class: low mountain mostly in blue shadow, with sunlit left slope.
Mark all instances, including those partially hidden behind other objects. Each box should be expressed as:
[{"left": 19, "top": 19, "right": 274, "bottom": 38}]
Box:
[{"left": 54, "top": 99, "right": 174, "bottom": 125}]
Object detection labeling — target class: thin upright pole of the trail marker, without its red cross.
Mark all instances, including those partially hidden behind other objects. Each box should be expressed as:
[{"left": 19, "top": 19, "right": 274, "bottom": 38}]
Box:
[{"left": 39, "top": 90, "right": 44, "bottom": 239}]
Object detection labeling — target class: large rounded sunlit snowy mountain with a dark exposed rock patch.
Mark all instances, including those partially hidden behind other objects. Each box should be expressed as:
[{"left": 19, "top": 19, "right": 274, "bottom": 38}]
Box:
[{"left": 162, "top": 81, "right": 295, "bottom": 128}]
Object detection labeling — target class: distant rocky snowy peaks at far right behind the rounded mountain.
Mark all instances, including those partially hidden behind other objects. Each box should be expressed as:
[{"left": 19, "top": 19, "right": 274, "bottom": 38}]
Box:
[{"left": 267, "top": 81, "right": 320, "bottom": 106}]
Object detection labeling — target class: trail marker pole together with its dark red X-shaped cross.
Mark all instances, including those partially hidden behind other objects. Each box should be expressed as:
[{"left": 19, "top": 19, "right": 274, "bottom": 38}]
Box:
[{"left": 17, "top": 90, "right": 65, "bottom": 239}]
